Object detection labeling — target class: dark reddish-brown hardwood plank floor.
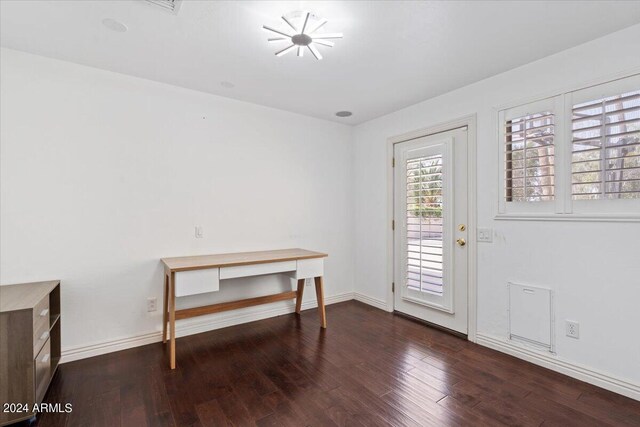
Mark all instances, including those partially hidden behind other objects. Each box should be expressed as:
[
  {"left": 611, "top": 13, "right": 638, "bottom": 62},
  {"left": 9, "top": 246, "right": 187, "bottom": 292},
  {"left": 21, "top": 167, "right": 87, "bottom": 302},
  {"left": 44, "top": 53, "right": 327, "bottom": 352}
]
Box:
[{"left": 26, "top": 301, "right": 640, "bottom": 427}]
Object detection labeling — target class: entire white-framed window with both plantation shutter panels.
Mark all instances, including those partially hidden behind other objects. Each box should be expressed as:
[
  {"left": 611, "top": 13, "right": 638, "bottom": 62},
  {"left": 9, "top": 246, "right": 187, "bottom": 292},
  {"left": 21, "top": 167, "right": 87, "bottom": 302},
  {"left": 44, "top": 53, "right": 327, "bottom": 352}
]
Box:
[{"left": 496, "top": 74, "right": 640, "bottom": 221}]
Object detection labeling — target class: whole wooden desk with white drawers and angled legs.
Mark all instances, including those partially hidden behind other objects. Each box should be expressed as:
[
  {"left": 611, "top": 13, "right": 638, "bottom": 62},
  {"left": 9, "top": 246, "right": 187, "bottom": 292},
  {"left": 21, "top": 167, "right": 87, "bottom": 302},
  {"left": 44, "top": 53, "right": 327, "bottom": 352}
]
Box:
[{"left": 162, "top": 249, "right": 327, "bottom": 369}]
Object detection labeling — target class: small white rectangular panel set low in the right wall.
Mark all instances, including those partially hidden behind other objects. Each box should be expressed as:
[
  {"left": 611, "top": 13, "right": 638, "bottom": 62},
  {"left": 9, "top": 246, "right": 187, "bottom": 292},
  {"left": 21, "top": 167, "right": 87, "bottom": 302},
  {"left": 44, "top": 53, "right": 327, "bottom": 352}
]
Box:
[{"left": 508, "top": 283, "right": 554, "bottom": 352}]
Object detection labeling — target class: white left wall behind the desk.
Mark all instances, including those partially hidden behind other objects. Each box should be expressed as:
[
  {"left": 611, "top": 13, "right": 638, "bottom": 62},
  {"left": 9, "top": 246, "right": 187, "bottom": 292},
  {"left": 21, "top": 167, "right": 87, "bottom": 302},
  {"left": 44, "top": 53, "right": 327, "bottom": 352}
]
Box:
[{"left": 0, "top": 49, "right": 354, "bottom": 358}]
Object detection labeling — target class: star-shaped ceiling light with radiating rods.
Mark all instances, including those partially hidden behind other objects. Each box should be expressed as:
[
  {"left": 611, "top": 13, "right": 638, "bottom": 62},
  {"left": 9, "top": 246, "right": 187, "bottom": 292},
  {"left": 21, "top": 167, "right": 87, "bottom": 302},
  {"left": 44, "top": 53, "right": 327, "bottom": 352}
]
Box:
[{"left": 262, "top": 12, "right": 342, "bottom": 59}]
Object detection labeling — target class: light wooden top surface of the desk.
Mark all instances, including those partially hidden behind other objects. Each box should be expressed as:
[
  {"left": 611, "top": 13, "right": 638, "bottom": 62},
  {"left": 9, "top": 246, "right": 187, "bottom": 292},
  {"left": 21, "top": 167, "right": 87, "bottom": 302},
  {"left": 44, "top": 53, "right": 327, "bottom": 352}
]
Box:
[{"left": 162, "top": 248, "right": 328, "bottom": 271}]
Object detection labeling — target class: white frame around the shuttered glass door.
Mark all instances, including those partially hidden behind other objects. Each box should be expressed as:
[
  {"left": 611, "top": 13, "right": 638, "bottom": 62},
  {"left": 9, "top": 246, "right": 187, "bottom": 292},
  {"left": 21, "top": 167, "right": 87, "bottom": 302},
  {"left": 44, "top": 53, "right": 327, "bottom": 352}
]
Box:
[{"left": 386, "top": 114, "right": 478, "bottom": 342}]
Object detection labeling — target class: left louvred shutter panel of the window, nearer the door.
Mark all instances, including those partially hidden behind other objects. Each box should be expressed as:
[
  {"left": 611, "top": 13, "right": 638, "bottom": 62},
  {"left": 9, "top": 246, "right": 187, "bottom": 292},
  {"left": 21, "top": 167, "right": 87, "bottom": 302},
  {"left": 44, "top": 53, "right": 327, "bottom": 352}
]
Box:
[{"left": 504, "top": 111, "right": 555, "bottom": 202}]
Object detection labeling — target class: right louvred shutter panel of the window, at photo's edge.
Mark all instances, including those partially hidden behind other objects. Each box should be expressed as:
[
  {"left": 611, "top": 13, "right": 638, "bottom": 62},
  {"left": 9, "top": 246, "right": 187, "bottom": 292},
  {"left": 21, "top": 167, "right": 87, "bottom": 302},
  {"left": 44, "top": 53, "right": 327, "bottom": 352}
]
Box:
[{"left": 571, "top": 89, "right": 640, "bottom": 200}]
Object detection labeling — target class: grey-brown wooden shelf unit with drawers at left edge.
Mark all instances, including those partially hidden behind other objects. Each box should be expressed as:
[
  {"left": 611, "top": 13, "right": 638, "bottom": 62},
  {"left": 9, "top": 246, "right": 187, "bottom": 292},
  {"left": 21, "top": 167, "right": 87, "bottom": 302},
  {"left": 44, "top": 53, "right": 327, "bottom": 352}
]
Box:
[{"left": 0, "top": 280, "right": 61, "bottom": 426}]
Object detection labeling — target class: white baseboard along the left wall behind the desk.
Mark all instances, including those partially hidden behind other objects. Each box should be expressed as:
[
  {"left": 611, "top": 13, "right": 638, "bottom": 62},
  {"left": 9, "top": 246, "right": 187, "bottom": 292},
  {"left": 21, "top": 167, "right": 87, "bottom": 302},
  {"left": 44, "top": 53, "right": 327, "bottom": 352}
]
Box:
[{"left": 60, "top": 292, "right": 353, "bottom": 363}]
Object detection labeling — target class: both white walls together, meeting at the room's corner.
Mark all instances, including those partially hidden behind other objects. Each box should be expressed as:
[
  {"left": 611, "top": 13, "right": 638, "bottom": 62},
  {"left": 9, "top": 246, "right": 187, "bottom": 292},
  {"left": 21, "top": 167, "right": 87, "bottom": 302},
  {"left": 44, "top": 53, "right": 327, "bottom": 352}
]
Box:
[{"left": 0, "top": 22, "right": 640, "bottom": 398}]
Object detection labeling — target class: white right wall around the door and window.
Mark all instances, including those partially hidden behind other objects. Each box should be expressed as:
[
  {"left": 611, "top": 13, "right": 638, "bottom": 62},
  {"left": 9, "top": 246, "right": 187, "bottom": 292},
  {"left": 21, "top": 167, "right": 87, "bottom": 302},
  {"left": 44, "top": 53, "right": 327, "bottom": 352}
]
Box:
[{"left": 354, "top": 25, "right": 640, "bottom": 396}]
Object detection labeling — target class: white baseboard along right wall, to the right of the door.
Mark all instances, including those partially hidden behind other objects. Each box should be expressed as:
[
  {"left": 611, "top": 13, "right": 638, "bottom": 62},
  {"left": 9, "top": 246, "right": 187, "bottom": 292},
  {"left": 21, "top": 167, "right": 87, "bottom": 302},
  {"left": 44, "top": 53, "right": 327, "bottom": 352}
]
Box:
[{"left": 477, "top": 333, "right": 640, "bottom": 400}]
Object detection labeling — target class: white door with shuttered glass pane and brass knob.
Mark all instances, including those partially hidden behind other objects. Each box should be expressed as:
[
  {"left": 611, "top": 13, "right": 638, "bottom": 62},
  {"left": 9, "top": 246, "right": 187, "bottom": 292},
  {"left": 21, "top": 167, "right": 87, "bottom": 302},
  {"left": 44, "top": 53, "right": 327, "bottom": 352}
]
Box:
[{"left": 394, "top": 127, "right": 468, "bottom": 334}]
